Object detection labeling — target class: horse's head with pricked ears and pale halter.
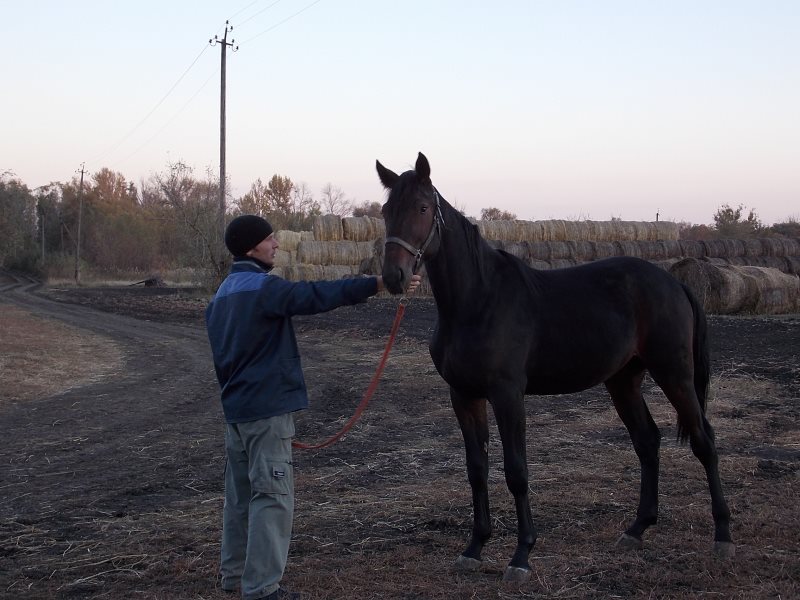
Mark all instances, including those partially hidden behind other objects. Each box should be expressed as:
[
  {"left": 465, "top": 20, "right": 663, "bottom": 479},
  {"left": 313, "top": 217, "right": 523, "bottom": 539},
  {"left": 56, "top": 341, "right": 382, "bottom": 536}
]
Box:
[{"left": 375, "top": 152, "right": 442, "bottom": 294}]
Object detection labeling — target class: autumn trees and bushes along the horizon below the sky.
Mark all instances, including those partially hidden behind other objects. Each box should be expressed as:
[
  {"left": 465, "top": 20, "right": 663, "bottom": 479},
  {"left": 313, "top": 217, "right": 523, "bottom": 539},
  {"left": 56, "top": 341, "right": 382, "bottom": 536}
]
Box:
[{"left": 0, "top": 161, "right": 800, "bottom": 285}]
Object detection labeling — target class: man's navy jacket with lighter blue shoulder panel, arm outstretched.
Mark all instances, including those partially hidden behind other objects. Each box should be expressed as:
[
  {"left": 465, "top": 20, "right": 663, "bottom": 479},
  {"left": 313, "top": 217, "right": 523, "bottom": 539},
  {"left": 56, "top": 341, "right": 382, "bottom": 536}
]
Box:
[{"left": 206, "top": 259, "right": 378, "bottom": 423}]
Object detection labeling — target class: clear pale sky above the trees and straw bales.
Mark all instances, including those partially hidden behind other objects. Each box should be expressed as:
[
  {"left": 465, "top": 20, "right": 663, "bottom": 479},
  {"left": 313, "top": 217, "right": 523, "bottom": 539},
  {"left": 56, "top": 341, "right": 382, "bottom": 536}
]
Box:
[{"left": 0, "top": 0, "right": 800, "bottom": 224}]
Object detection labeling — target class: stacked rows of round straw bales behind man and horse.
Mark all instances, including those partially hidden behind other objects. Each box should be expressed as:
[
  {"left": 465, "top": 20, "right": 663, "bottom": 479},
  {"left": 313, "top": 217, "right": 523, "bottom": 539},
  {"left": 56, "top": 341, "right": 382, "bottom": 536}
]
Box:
[{"left": 275, "top": 215, "right": 800, "bottom": 314}]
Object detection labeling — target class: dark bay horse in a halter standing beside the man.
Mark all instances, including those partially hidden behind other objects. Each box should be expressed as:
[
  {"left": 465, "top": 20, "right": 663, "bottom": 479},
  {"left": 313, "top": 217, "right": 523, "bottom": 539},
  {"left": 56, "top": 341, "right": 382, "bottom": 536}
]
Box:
[{"left": 375, "top": 153, "right": 735, "bottom": 582}]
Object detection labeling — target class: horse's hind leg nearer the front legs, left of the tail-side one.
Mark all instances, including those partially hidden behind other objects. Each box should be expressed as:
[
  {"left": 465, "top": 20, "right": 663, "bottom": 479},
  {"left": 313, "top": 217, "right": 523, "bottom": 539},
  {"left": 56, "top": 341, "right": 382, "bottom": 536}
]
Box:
[{"left": 606, "top": 363, "right": 661, "bottom": 549}]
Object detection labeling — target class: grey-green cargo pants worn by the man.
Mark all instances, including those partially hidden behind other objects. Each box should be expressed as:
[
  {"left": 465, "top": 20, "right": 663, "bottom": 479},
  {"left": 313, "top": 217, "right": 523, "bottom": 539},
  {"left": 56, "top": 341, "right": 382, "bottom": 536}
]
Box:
[{"left": 220, "top": 413, "right": 294, "bottom": 600}]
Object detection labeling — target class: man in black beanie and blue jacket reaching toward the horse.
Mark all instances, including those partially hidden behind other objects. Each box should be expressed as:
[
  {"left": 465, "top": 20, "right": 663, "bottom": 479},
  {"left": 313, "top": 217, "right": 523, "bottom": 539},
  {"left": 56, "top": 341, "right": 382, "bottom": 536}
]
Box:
[{"left": 206, "top": 215, "right": 420, "bottom": 600}]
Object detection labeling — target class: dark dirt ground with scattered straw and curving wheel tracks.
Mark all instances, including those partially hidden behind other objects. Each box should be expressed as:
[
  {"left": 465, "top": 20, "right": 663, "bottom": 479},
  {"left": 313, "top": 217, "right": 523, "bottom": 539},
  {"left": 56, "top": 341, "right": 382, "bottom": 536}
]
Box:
[{"left": 0, "top": 276, "right": 800, "bottom": 600}]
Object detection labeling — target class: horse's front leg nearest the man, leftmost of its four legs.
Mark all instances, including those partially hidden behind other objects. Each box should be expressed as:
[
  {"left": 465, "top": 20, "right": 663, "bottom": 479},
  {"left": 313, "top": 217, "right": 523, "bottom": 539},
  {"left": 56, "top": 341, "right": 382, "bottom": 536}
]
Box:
[{"left": 450, "top": 387, "right": 492, "bottom": 571}]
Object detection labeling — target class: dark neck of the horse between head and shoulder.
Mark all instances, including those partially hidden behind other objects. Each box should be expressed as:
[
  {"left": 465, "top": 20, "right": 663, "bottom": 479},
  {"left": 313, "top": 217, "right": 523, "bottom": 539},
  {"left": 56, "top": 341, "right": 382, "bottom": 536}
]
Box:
[{"left": 425, "top": 203, "right": 491, "bottom": 317}]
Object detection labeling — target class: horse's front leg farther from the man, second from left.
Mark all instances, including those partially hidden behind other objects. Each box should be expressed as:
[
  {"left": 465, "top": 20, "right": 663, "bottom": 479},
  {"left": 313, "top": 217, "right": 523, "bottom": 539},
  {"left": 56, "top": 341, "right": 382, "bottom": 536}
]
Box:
[{"left": 490, "top": 382, "right": 536, "bottom": 582}]
